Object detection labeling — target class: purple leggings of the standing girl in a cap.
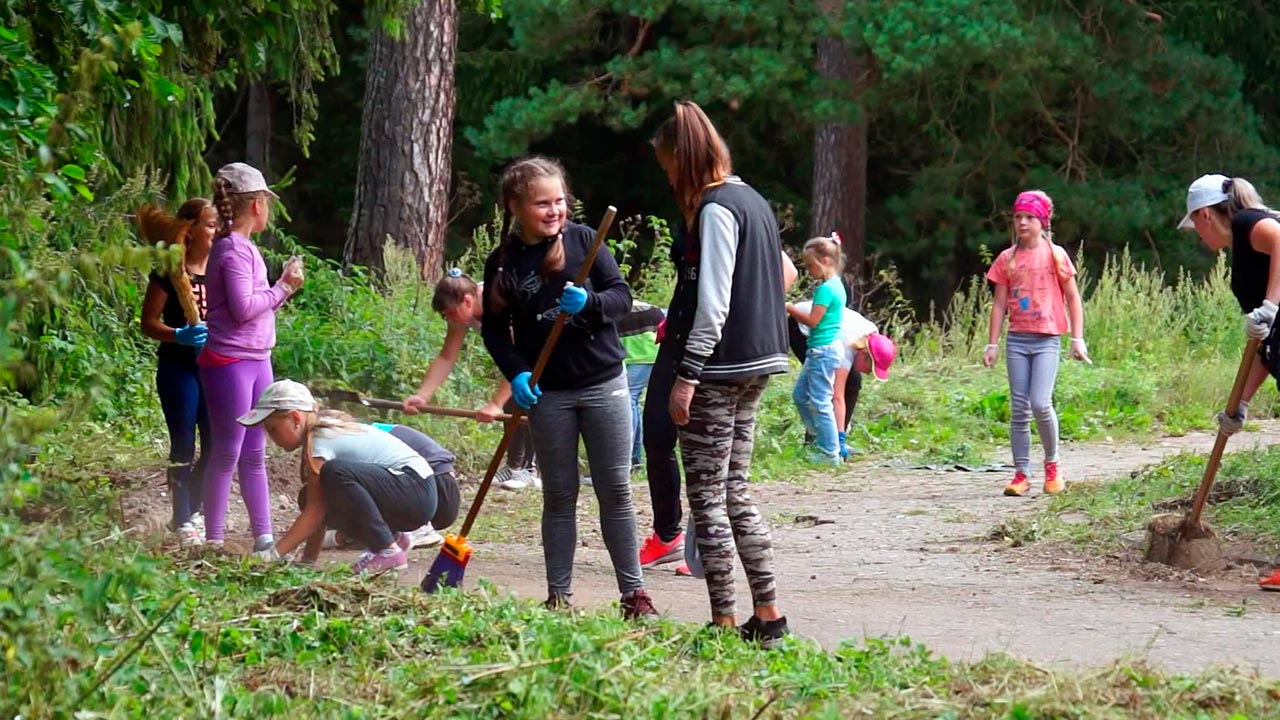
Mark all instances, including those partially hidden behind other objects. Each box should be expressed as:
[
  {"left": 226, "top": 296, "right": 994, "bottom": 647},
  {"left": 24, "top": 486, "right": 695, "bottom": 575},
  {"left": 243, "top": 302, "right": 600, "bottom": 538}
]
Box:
[{"left": 200, "top": 360, "right": 273, "bottom": 541}]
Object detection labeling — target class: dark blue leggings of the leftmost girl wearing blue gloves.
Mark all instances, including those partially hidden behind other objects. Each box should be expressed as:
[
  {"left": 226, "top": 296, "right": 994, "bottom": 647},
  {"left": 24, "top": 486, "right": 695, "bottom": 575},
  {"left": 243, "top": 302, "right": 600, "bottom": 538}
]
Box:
[{"left": 156, "top": 357, "right": 211, "bottom": 528}]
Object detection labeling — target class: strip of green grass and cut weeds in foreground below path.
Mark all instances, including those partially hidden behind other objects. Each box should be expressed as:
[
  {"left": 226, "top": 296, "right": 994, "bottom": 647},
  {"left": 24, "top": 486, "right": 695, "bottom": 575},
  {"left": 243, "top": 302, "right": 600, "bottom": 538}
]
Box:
[{"left": 0, "top": 504, "right": 1280, "bottom": 719}]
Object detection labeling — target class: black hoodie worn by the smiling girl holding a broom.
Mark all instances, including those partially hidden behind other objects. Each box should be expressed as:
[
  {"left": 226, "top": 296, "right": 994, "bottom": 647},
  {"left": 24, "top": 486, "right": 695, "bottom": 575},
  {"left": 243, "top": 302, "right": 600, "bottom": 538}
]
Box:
[{"left": 480, "top": 222, "right": 631, "bottom": 391}]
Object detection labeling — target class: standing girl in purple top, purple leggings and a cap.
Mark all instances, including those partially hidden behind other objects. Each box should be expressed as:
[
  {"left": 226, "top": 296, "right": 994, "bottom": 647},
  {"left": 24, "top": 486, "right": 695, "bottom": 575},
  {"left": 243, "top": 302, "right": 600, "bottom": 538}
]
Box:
[{"left": 196, "top": 163, "right": 302, "bottom": 553}]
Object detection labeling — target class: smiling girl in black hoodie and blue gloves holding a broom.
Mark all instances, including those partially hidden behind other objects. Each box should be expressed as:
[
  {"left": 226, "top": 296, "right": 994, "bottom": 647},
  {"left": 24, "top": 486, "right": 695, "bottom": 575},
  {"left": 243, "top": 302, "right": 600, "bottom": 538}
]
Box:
[{"left": 480, "top": 156, "right": 657, "bottom": 619}]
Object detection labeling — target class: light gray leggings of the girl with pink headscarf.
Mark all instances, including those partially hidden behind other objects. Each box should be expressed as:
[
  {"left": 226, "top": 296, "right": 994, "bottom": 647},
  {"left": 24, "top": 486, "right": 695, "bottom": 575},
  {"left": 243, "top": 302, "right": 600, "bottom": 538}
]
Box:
[{"left": 1005, "top": 333, "right": 1062, "bottom": 473}]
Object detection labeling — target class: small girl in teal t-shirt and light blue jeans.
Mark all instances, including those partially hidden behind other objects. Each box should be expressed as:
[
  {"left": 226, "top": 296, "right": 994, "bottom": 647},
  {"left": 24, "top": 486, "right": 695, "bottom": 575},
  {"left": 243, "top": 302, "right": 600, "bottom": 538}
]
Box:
[{"left": 787, "top": 233, "right": 849, "bottom": 465}]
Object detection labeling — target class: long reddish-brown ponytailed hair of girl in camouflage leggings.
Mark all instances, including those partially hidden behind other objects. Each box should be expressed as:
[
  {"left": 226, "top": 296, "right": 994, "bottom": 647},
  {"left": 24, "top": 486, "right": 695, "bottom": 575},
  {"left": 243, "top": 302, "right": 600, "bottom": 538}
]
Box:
[{"left": 653, "top": 101, "right": 733, "bottom": 219}]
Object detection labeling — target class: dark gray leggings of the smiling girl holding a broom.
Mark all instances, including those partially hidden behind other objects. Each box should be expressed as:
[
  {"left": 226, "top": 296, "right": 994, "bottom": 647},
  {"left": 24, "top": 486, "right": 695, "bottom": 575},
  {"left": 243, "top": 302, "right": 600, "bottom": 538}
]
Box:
[{"left": 529, "top": 373, "right": 644, "bottom": 597}]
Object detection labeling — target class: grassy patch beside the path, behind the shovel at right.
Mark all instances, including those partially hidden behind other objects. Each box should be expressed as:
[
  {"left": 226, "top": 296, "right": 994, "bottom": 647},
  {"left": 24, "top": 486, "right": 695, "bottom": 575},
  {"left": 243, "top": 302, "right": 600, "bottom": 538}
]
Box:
[{"left": 995, "top": 447, "right": 1280, "bottom": 551}]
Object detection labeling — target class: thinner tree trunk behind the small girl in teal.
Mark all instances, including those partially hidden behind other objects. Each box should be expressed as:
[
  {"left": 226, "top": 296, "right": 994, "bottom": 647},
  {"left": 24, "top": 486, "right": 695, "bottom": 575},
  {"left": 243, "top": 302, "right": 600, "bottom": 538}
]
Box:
[{"left": 810, "top": 37, "right": 869, "bottom": 301}]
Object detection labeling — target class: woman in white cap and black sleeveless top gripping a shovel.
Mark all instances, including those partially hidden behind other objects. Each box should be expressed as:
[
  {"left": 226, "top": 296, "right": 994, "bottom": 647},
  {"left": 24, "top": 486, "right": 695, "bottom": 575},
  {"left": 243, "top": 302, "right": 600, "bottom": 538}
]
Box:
[{"left": 1178, "top": 174, "right": 1280, "bottom": 591}]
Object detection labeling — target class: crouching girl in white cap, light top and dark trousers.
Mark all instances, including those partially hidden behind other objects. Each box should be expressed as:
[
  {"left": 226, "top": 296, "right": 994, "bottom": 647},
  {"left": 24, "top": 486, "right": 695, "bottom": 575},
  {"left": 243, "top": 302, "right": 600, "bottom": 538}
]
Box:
[{"left": 237, "top": 380, "right": 439, "bottom": 573}]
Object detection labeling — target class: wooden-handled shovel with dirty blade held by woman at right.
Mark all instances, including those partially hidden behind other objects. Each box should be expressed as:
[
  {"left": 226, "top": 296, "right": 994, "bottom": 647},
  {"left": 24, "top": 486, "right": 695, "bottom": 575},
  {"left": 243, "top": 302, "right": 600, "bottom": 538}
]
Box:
[{"left": 1146, "top": 340, "right": 1261, "bottom": 570}]
